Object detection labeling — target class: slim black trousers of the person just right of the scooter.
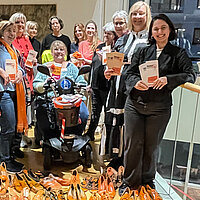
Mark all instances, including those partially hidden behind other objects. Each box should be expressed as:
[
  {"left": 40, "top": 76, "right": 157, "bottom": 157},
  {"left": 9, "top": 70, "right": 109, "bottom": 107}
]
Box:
[{"left": 86, "top": 89, "right": 108, "bottom": 139}]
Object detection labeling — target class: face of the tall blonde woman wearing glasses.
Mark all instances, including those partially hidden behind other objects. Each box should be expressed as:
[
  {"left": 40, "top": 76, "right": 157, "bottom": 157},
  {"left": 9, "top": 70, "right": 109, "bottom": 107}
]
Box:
[{"left": 131, "top": 5, "right": 147, "bottom": 32}]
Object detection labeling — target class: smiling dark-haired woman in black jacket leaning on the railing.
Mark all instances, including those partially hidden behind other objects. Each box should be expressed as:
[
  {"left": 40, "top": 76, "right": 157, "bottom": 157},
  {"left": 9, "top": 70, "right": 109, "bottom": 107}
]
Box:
[{"left": 119, "top": 14, "right": 196, "bottom": 194}]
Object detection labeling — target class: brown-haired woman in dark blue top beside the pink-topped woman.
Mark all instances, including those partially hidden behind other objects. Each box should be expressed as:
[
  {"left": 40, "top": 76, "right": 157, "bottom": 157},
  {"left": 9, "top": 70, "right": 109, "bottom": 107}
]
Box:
[{"left": 70, "top": 23, "right": 86, "bottom": 53}]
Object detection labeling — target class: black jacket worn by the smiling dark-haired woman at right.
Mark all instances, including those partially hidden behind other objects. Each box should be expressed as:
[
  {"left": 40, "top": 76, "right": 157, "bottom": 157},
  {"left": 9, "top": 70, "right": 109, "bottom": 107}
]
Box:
[{"left": 126, "top": 43, "right": 196, "bottom": 108}]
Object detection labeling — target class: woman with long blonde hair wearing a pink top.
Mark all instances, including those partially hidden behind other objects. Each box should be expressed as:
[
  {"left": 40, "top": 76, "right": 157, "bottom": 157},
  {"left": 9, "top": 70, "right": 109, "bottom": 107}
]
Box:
[{"left": 79, "top": 20, "right": 101, "bottom": 64}]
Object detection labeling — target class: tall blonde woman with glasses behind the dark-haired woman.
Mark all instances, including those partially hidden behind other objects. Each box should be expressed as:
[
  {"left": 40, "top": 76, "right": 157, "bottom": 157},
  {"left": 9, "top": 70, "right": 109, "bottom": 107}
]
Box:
[{"left": 104, "top": 1, "right": 151, "bottom": 169}]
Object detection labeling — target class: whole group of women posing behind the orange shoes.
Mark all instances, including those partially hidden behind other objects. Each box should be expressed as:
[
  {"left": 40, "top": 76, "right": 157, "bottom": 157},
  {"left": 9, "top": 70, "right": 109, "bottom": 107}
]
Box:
[{"left": 0, "top": 1, "right": 196, "bottom": 194}]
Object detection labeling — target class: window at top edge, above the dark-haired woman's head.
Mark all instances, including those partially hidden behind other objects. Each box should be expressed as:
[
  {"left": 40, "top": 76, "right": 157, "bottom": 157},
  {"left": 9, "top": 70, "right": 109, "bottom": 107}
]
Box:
[{"left": 150, "top": 0, "right": 183, "bottom": 13}]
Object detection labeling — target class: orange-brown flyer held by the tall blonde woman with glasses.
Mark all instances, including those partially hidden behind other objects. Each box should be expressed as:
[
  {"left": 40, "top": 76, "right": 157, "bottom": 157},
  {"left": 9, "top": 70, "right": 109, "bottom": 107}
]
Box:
[{"left": 106, "top": 52, "right": 124, "bottom": 76}]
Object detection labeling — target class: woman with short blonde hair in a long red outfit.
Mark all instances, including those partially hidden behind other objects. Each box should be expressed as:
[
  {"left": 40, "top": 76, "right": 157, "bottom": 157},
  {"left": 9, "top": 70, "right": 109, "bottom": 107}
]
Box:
[{"left": 10, "top": 13, "right": 36, "bottom": 152}]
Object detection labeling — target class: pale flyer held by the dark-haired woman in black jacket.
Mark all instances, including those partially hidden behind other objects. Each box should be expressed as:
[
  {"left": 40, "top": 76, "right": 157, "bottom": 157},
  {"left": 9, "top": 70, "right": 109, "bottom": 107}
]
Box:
[{"left": 139, "top": 60, "right": 159, "bottom": 87}]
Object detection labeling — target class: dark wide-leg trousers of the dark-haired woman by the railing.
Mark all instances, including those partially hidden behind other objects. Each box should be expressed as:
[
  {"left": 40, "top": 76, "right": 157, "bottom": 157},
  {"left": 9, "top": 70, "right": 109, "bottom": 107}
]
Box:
[{"left": 124, "top": 96, "right": 171, "bottom": 188}]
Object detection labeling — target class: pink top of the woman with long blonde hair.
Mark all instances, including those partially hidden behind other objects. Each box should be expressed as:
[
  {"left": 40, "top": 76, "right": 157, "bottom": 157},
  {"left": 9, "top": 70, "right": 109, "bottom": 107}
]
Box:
[{"left": 79, "top": 40, "right": 102, "bottom": 60}]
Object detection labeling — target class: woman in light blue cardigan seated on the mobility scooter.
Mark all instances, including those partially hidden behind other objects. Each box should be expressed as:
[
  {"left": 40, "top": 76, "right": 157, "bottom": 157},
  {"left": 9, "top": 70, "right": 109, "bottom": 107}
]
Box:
[{"left": 33, "top": 40, "right": 89, "bottom": 143}]
